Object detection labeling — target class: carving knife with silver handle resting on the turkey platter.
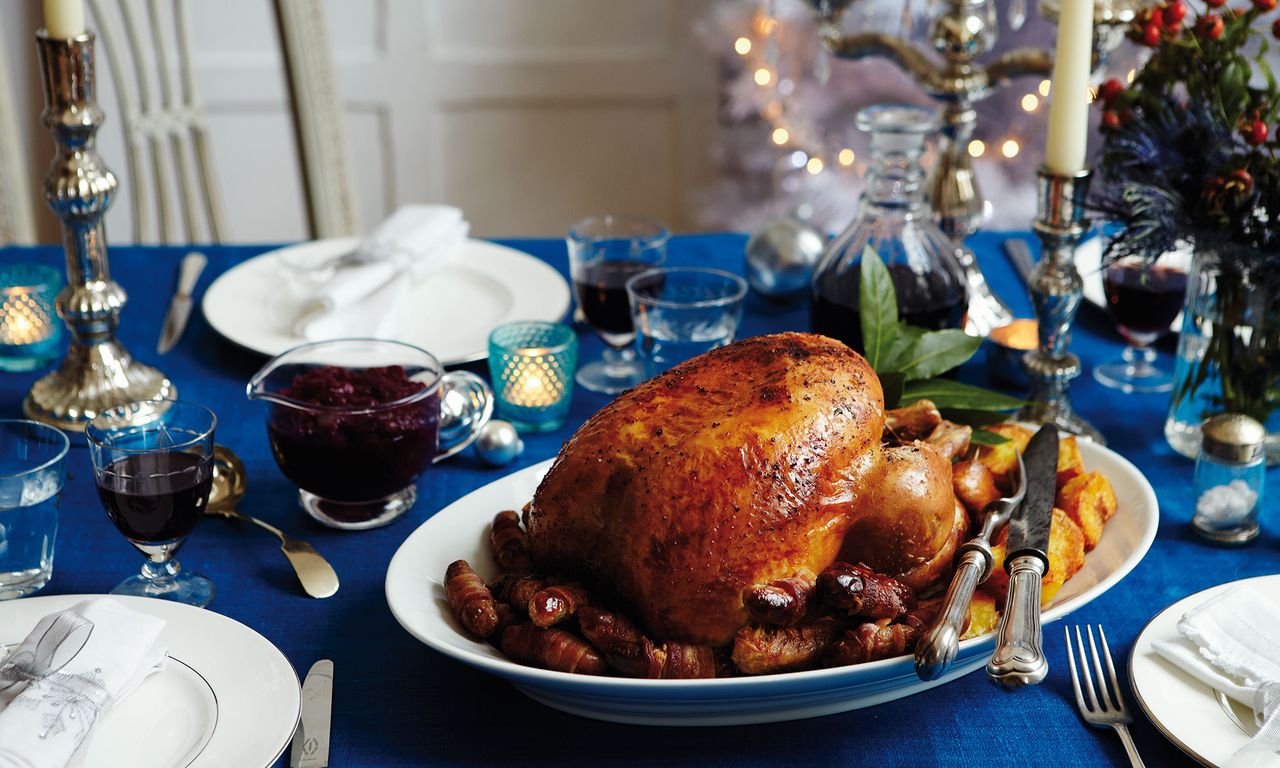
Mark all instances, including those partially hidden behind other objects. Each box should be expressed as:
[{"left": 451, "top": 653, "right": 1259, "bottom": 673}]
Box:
[{"left": 987, "top": 424, "right": 1057, "bottom": 689}]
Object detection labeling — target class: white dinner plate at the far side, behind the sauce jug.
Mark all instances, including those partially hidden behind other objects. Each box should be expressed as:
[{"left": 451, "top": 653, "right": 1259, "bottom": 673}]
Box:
[{"left": 201, "top": 237, "right": 570, "bottom": 365}]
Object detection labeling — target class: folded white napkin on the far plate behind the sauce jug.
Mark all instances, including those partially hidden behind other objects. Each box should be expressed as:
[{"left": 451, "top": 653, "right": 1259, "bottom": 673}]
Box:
[{"left": 294, "top": 205, "right": 470, "bottom": 342}]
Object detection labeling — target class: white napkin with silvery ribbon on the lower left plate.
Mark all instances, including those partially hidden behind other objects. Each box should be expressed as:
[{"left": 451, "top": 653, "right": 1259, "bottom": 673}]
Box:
[{"left": 0, "top": 598, "right": 165, "bottom": 768}]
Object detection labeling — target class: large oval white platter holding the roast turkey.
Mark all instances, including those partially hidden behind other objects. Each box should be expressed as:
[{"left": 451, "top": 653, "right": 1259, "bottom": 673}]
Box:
[{"left": 387, "top": 440, "right": 1160, "bottom": 726}]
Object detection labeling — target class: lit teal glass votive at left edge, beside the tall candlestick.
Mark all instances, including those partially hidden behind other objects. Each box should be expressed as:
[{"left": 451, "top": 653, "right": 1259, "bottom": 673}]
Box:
[{"left": 0, "top": 264, "right": 63, "bottom": 371}]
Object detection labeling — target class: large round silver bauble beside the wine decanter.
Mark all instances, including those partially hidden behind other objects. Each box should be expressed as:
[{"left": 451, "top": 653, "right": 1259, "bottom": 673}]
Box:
[{"left": 746, "top": 216, "right": 827, "bottom": 301}]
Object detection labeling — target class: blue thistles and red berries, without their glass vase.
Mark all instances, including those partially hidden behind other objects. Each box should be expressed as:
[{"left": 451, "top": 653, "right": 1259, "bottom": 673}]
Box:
[{"left": 1094, "top": 0, "right": 1280, "bottom": 259}]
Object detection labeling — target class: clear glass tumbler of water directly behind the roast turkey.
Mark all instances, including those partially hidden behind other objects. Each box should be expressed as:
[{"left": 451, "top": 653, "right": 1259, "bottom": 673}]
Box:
[{"left": 627, "top": 268, "right": 746, "bottom": 375}]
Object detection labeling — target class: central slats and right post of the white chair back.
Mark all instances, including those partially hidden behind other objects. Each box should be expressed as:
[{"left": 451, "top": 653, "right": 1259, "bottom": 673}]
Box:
[{"left": 88, "top": 0, "right": 358, "bottom": 243}]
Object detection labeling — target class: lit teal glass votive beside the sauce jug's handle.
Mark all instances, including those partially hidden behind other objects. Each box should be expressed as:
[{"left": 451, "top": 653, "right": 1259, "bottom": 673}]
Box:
[{"left": 489, "top": 321, "right": 577, "bottom": 433}]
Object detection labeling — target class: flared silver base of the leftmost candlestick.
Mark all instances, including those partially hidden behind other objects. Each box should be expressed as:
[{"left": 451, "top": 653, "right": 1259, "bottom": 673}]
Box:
[{"left": 22, "top": 340, "right": 178, "bottom": 431}]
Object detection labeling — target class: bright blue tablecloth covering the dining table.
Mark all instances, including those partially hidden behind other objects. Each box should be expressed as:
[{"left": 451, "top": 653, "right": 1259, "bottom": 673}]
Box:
[{"left": 0, "top": 233, "right": 1280, "bottom": 768}]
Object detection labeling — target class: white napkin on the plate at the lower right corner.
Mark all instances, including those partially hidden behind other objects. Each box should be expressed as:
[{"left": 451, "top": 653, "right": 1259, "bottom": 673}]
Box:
[{"left": 1153, "top": 584, "right": 1280, "bottom": 768}]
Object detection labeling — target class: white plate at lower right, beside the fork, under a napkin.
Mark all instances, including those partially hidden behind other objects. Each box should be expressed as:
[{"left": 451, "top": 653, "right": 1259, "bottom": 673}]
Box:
[{"left": 1129, "top": 575, "right": 1280, "bottom": 768}]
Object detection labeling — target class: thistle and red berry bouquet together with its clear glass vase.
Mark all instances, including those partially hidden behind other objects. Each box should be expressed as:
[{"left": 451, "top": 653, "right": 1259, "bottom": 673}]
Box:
[{"left": 1093, "top": 0, "right": 1280, "bottom": 450}]
